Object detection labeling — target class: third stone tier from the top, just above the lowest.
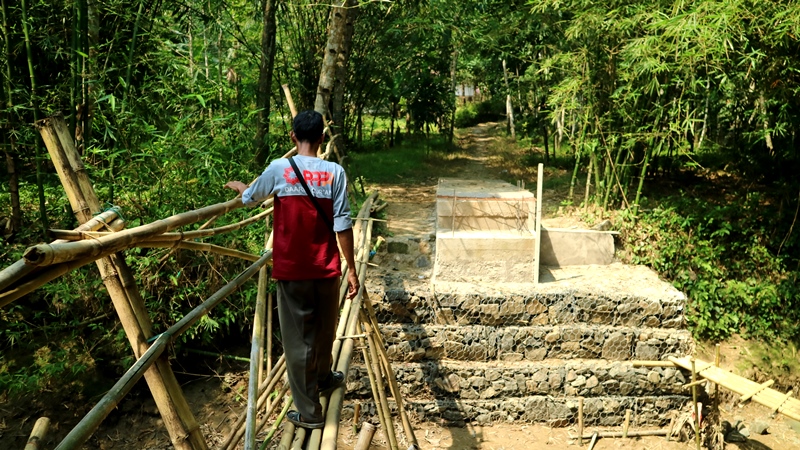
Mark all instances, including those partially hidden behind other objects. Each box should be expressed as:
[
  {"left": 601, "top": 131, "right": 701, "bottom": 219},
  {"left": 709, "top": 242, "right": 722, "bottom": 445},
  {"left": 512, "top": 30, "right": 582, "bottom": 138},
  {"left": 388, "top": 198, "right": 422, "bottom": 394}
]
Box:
[{"left": 347, "top": 360, "right": 687, "bottom": 400}]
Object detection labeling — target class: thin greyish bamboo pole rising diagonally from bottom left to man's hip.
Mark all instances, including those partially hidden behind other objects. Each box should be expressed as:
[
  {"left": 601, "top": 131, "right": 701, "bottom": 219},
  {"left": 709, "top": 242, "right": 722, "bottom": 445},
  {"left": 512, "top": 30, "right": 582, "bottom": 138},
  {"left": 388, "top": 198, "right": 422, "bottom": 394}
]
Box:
[{"left": 56, "top": 252, "right": 272, "bottom": 450}]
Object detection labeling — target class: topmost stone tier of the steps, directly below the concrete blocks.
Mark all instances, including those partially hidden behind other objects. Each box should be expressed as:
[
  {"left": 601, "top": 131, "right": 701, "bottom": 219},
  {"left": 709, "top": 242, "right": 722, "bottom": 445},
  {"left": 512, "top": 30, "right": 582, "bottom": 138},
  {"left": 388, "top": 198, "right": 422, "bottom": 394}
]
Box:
[{"left": 367, "top": 282, "right": 686, "bottom": 328}]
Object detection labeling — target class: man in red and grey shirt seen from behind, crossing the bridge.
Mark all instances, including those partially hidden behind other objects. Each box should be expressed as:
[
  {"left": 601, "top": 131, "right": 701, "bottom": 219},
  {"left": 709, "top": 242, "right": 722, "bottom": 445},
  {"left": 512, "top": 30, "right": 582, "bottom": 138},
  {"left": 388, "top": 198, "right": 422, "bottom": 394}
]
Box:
[{"left": 225, "top": 111, "right": 359, "bottom": 429}]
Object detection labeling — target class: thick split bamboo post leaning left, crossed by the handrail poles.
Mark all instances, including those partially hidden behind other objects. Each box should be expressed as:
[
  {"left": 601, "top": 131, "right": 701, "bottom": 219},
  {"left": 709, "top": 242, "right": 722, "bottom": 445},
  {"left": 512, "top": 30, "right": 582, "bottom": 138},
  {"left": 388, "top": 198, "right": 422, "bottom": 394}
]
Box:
[{"left": 36, "top": 116, "right": 206, "bottom": 450}]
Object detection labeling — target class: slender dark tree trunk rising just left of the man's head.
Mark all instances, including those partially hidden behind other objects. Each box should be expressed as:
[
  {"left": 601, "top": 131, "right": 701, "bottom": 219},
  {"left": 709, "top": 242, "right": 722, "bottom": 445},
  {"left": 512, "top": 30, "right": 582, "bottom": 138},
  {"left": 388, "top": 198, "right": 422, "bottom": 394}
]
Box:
[{"left": 255, "top": 0, "right": 277, "bottom": 167}]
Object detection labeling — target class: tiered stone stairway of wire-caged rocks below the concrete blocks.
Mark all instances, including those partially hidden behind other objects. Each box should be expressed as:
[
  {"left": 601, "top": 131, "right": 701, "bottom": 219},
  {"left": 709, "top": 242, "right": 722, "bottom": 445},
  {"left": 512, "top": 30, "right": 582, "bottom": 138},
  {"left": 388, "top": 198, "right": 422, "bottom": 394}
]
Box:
[{"left": 343, "top": 178, "right": 694, "bottom": 427}]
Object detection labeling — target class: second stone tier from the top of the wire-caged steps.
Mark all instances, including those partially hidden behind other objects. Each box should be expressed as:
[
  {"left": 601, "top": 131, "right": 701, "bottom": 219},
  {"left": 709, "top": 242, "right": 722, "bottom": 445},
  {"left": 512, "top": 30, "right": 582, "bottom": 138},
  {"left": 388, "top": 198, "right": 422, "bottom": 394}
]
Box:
[{"left": 381, "top": 324, "right": 694, "bottom": 361}]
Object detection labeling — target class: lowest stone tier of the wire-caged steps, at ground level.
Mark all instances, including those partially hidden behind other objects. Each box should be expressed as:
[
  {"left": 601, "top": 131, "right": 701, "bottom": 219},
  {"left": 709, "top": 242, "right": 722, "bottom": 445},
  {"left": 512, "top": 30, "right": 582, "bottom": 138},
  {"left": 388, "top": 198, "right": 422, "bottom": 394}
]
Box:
[{"left": 342, "top": 395, "right": 691, "bottom": 428}]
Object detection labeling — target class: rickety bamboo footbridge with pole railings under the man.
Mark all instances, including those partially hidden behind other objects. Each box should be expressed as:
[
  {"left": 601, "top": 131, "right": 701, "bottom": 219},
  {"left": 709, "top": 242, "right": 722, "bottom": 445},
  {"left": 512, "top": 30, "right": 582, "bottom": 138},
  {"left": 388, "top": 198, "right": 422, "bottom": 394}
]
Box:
[{"left": 0, "top": 116, "right": 417, "bottom": 450}]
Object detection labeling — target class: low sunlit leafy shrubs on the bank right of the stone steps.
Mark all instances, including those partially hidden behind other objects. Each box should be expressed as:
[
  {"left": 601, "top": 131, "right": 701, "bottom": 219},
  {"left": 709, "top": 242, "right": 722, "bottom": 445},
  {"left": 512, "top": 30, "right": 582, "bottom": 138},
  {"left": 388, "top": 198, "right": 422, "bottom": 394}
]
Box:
[{"left": 623, "top": 195, "right": 800, "bottom": 341}]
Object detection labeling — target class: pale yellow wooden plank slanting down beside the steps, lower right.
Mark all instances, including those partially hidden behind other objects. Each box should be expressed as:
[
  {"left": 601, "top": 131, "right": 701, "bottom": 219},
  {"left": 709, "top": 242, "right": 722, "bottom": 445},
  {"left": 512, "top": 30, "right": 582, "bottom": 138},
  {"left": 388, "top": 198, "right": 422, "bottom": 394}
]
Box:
[{"left": 669, "top": 357, "right": 800, "bottom": 420}]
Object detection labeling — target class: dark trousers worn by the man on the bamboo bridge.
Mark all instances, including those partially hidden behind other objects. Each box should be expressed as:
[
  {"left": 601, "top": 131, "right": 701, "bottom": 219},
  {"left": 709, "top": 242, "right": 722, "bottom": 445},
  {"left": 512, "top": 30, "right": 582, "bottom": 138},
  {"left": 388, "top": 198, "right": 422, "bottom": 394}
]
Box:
[{"left": 278, "top": 278, "right": 339, "bottom": 422}]
